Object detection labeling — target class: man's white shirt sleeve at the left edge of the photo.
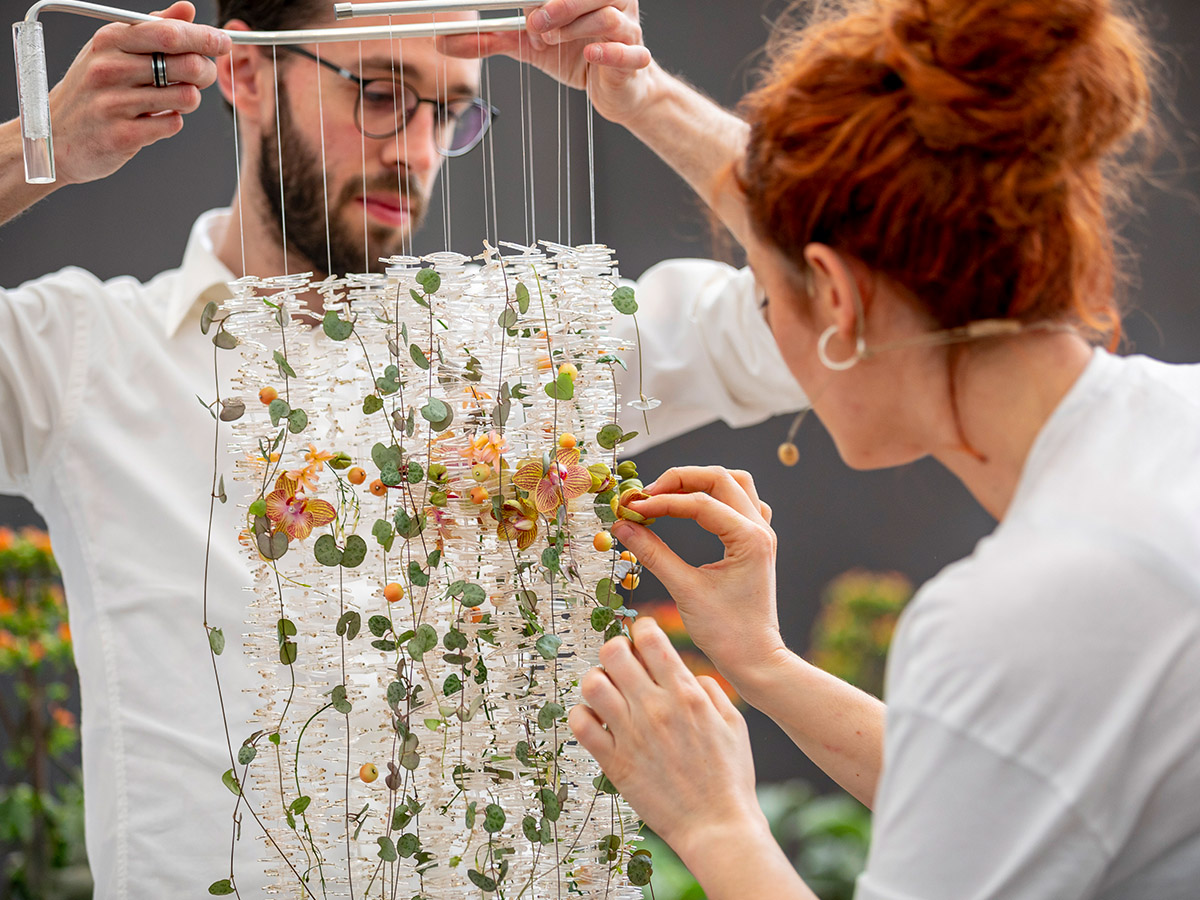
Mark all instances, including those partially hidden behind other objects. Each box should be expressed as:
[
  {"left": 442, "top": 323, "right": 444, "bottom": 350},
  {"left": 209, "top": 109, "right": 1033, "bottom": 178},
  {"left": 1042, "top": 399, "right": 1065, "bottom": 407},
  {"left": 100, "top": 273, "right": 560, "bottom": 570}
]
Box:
[{"left": 0, "top": 271, "right": 90, "bottom": 496}]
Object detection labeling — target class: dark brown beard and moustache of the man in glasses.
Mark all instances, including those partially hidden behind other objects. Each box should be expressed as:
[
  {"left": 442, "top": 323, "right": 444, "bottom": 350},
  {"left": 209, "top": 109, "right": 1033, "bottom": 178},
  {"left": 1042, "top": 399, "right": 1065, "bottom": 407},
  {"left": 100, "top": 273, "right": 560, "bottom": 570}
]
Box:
[{"left": 258, "top": 85, "right": 425, "bottom": 275}]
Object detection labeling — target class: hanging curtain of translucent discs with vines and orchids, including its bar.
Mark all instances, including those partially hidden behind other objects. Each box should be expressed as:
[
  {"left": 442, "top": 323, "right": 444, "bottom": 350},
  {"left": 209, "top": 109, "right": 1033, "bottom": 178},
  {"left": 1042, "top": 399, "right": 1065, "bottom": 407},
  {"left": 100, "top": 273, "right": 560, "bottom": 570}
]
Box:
[{"left": 16, "top": 0, "right": 658, "bottom": 900}]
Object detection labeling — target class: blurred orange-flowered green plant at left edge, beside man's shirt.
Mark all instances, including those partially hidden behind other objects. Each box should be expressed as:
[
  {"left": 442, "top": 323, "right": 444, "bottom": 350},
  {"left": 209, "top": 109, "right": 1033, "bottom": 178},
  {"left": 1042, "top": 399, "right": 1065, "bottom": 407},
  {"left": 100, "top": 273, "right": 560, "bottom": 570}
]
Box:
[{"left": 0, "top": 528, "right": 91, "bottom": 900}]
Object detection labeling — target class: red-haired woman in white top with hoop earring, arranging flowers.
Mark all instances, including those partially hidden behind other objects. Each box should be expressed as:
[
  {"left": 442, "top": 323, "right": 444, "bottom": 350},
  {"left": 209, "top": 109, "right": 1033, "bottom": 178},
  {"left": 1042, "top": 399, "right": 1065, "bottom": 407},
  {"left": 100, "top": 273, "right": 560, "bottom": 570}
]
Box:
[{"left": 570, "top": 0, "right": 1200, "bottom": 900}]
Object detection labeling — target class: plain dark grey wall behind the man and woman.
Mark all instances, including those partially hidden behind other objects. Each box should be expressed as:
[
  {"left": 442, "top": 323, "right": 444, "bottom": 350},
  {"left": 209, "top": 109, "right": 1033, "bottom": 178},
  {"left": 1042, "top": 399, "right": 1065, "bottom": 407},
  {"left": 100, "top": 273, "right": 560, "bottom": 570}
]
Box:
[{"left": 0, "top": 0, "right": 1200, "bottom": 780}]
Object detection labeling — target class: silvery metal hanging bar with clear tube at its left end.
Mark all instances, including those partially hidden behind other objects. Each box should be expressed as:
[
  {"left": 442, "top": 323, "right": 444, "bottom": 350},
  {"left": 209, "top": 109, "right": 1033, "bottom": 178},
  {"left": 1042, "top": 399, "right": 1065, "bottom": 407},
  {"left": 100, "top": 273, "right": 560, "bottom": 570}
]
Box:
[{"left": 12, "top": 0, "right": 526, "bottom": 185}]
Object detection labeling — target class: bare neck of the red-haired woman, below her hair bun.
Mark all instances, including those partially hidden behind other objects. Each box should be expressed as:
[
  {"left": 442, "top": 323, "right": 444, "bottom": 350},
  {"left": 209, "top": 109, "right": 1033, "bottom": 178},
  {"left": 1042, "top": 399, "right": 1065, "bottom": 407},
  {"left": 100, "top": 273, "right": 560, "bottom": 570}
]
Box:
[{"left": 932, "top": 332, "right": 1092, "bottom": 520}]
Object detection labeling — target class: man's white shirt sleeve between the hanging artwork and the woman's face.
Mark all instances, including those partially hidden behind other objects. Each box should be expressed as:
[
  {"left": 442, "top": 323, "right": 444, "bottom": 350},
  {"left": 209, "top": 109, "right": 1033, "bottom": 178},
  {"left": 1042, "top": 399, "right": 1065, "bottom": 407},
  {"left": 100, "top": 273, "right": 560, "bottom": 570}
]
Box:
[{"left": 613, "top": 259, "right": 808, "bottom": 456}]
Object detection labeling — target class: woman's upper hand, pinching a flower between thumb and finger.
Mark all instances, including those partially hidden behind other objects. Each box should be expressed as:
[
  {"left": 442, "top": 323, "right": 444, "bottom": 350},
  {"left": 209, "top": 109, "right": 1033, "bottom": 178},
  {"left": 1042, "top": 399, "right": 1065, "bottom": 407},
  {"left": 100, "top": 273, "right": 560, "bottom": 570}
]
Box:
[{"left": 612, "top": 466, "right": 788, "bottom": 685}]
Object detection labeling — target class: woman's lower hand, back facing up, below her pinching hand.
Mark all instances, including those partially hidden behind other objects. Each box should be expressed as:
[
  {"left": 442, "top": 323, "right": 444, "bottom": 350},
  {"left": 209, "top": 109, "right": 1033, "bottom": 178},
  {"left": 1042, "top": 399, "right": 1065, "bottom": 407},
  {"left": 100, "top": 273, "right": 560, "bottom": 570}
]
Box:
[{"left": 569, "top": 618, "right": 770, "bottom": 863}]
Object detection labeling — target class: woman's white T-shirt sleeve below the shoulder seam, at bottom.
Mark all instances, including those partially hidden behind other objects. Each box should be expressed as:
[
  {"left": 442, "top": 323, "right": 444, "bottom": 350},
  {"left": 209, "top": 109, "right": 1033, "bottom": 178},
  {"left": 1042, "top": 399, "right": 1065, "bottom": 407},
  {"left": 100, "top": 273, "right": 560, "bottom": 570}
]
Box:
[{"left": 854, "top": 709, "right": 1109, "bottom": 900}]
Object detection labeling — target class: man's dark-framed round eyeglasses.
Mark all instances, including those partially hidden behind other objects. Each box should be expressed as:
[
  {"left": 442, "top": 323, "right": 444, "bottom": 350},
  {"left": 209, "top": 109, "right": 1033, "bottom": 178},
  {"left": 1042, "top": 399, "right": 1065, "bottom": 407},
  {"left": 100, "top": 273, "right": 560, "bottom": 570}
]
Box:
[{"left": 280, "top": 47, "right": 500, "bottom": 156}]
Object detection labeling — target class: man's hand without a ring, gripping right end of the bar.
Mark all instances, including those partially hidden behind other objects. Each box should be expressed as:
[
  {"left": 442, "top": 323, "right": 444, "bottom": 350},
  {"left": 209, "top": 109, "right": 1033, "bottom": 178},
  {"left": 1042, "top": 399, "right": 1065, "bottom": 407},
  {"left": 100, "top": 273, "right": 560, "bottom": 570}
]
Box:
[{"left": 438, "top": 0, "right": 652, "bottom": 124}]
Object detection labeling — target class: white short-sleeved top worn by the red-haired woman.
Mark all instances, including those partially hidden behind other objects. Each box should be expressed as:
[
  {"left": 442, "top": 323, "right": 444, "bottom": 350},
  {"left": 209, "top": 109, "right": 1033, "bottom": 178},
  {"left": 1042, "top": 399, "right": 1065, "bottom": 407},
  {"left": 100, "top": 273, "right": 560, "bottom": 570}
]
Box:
[{"left": 856, "top": 350, "right": 1200, "bottom": 900}]
